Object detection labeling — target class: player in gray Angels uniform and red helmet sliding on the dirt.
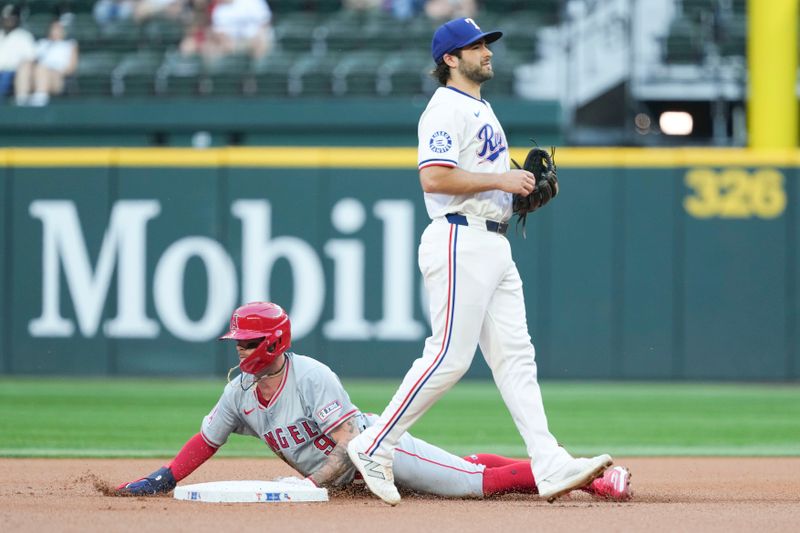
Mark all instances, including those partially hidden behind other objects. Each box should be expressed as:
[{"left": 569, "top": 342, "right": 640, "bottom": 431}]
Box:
[{"left": 117, "top": 302, "right": 630, "bottom": 501}]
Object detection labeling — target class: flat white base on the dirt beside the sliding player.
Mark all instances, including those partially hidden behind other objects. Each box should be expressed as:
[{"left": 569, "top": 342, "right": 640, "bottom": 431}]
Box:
[{"left": 175, "top": 481, "right": 328, "bottom": 503}]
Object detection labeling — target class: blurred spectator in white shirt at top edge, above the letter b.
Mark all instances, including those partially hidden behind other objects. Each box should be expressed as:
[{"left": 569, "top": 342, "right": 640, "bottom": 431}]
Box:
[{"left": 201, "top": 0, "right": 275, "bottom": 60}]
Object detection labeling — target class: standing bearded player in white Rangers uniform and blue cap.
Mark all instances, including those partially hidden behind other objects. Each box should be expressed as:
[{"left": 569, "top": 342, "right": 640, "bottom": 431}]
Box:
[{"left": 348, "top": 18, "right": 612, "bottom": 505}]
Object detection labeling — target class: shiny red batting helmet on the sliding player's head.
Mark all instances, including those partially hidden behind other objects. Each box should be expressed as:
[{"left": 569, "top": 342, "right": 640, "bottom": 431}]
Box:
[{"left": 219, "top": 302, "right": 292, "bottom": 374}]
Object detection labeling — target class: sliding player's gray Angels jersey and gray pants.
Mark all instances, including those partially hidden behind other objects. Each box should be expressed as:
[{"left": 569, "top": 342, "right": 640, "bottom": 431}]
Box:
[{"left": 201, "top": 352, "right": 484, "bottom": 497}]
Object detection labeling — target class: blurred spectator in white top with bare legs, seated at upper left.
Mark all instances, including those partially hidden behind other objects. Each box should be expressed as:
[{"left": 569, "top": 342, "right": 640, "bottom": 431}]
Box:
[{"left": 14, "top": 18, "right": 78, "bottom": 107}]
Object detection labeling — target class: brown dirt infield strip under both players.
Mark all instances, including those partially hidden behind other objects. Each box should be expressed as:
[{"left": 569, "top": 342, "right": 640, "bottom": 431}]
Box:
[{"left": 0, "top": 458, "right": 800, "bottom": 533}]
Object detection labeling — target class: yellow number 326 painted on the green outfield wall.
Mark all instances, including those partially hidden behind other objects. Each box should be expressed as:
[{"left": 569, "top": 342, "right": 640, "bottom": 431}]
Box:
[{"left": 683, "top": 168, "right": 786, "bottom": 218}]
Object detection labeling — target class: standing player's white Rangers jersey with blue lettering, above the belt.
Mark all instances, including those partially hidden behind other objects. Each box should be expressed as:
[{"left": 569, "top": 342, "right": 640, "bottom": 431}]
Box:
[{"left": 417, "top": 87, "right": 512, "bottom": 222}]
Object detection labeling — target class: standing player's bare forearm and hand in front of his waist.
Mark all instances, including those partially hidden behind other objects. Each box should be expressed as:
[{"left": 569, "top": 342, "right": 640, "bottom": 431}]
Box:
[{"left": 419, "top": 166, "right": 536, "bottom": 195}]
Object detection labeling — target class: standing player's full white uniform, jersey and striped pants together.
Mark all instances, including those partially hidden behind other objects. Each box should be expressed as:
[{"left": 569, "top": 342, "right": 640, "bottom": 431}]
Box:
[{"left": 359, "top": 82, "right": 571, "bottom": 479}]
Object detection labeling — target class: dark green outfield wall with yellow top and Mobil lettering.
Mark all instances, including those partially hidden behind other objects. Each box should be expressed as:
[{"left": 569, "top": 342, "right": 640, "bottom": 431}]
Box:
[{"left": 0, "top": 146, "right": 800, "bottom": 381}]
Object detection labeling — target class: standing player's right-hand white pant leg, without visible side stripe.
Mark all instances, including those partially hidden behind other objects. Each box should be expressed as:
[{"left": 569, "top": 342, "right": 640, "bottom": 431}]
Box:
[{"left": 480, "top": 258, "right": 571, "bottom": 479}]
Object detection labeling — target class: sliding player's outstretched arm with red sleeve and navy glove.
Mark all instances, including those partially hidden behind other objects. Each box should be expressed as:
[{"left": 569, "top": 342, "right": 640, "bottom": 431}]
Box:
[{"left": 117, "top": 433, "right": 219, "bottom": 496}]
